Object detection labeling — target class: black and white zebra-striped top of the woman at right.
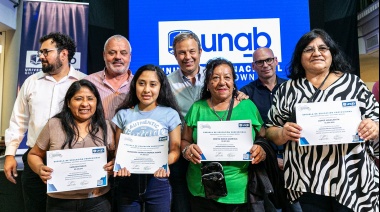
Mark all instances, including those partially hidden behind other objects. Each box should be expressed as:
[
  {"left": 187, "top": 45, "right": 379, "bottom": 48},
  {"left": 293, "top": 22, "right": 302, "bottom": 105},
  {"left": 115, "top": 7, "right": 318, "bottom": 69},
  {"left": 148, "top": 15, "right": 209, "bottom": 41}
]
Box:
[{"left": 267, "top": 73, "right": 379, "bottom": 212}]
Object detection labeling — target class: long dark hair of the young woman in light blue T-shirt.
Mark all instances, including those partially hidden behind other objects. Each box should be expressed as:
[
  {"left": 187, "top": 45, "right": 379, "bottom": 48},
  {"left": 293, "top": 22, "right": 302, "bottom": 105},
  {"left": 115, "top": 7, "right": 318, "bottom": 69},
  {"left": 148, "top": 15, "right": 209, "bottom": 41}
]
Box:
[{"left": 116, "top": 64, "right": 183, "bottom": 121}]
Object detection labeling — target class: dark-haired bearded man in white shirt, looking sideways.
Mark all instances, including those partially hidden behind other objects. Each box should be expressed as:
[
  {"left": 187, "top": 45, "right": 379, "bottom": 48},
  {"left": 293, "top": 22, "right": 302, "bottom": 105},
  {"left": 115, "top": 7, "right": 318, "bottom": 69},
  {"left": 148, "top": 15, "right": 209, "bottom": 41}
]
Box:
[{"left": 4, "top": 32, "right": 86, "bottom": 212}]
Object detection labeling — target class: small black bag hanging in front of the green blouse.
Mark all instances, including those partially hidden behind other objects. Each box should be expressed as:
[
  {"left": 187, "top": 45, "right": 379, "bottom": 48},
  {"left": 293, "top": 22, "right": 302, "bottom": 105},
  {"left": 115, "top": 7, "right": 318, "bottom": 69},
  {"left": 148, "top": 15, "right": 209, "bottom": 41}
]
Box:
[{"left": 201, "top": 162, "right": 227, "bottom": 199}]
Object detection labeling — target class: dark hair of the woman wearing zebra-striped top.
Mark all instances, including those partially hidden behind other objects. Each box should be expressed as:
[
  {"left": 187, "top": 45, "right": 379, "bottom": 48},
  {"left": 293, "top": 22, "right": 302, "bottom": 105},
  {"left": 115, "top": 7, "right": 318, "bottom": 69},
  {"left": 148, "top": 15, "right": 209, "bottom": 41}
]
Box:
[{"left": 288, "top": 29, "right": 353, "bottom": 80}]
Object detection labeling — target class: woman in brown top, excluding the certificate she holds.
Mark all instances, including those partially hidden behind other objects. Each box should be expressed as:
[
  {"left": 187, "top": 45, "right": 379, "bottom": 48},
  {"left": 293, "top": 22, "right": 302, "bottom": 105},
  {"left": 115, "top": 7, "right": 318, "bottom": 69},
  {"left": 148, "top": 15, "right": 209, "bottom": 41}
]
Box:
[{"left": 28, "top": 79, "right": 115, "bottom": 211}]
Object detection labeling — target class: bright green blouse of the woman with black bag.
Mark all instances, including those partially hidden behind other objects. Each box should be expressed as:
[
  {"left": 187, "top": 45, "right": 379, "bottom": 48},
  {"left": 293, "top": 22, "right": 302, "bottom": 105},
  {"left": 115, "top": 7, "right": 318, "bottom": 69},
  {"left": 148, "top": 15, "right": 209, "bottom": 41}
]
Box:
[{"left": 185, "top": 100, "right": 263, "bottom": 204}]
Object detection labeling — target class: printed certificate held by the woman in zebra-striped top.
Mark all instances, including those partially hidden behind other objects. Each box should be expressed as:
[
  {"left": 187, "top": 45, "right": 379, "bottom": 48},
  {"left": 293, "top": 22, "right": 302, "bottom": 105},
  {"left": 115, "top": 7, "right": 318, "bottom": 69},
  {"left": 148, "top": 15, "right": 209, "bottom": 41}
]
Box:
[{"left": 295, "top": 100, "right": 363, "bottom": 146}]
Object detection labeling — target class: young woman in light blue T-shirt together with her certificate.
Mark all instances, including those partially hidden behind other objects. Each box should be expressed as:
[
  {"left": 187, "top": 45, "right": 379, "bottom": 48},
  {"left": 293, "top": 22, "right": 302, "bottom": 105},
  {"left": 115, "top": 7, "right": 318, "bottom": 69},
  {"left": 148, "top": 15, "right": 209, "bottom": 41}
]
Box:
[{"left": 112, "top": 65, "right": 181, "bottom": 212}]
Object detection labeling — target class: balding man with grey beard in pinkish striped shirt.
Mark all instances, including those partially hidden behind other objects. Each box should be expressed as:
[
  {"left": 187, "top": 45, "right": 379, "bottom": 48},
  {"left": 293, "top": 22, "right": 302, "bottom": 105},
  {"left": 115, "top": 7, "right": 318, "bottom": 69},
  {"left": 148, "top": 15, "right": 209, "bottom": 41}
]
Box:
[{"left": 86, "top": 35, "right": 133, "bottom": 211}]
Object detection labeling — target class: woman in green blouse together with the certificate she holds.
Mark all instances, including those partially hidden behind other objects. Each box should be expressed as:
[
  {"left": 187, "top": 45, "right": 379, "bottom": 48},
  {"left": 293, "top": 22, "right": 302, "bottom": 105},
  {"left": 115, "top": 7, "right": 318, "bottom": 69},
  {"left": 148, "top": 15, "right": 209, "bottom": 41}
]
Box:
[{"left": 181, "top": 58, "right": 266, "bottom": 211}]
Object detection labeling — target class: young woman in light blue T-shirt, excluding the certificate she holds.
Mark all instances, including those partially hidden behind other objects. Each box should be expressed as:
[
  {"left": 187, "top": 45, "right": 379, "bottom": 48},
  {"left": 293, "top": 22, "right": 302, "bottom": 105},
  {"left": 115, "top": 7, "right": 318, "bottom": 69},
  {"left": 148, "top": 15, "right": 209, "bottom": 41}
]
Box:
[{"left": 112, "top": 65, "right": 181, "bottom": 212}]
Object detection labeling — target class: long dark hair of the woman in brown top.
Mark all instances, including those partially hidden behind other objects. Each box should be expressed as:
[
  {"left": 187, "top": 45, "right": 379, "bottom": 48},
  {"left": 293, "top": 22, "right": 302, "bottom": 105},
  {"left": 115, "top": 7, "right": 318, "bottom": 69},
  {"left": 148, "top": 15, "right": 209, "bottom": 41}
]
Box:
[{"left": 54, "top": 79, "right": 107, "bottom": 149}]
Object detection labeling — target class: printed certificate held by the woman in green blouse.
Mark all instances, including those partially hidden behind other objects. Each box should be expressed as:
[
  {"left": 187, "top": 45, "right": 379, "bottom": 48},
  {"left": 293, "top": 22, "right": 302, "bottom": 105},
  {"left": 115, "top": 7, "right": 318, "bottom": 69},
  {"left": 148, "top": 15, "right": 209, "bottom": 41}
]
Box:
[{"left": 197, "top": 120, "right": 253, "bottom": 161}]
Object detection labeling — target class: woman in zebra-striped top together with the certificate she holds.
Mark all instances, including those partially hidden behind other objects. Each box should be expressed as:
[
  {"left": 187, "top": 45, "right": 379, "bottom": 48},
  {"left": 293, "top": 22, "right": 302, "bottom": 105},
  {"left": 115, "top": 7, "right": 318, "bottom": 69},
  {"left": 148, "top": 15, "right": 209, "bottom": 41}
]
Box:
[{"left": 266, "top": 29, "right": 379, "bottom": 211}]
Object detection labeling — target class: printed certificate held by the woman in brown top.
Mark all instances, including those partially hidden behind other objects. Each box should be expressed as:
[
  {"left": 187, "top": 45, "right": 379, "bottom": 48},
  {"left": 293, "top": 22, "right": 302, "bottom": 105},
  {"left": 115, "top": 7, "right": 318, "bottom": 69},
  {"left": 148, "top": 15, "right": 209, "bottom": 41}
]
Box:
[{"left": 46, "top": 146, "right": 107, "bottom": 193}]
